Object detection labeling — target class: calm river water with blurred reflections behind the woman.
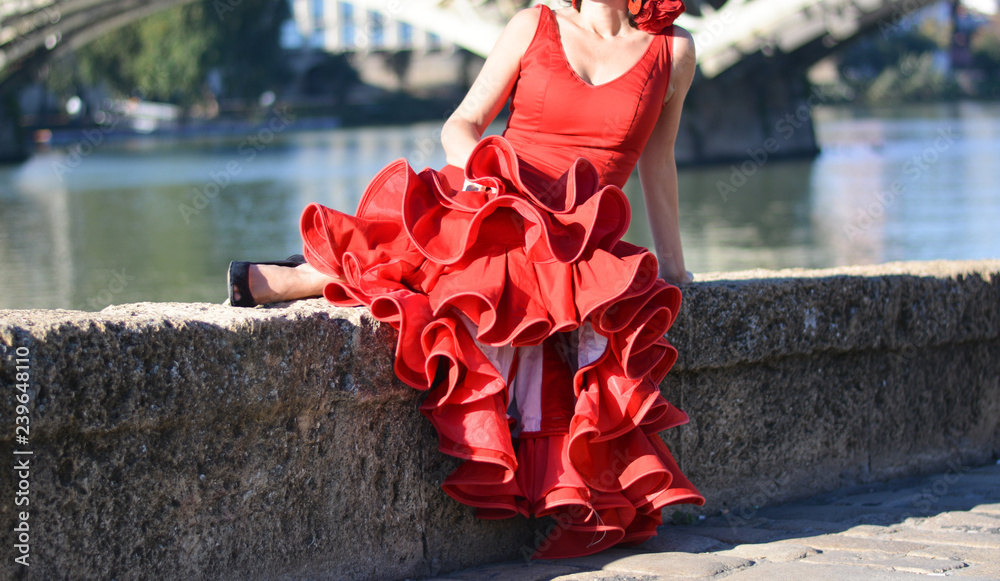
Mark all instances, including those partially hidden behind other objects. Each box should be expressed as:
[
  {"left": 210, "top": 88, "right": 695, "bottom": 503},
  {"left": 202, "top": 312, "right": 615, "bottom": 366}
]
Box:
[{"left": 0, "top": 103, "right": 1000, "bottom": 310}]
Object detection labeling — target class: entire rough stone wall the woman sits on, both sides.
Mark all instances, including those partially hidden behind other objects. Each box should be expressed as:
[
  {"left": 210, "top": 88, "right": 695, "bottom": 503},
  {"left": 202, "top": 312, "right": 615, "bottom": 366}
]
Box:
[{"left": 0, "top": 261, "right": 1000, "bottom": 579}]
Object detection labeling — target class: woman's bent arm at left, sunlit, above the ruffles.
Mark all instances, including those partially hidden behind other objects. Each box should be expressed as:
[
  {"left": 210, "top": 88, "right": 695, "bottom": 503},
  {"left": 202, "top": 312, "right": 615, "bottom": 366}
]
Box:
[{"left": 441, "top": 9, "right": 539, "bottom": 167}]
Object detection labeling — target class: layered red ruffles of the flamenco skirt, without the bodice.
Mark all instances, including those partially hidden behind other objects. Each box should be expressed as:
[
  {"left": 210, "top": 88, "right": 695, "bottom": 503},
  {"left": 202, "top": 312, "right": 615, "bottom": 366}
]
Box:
[{"left": 301, "top": 136, "right": 704, "bottom": 558}]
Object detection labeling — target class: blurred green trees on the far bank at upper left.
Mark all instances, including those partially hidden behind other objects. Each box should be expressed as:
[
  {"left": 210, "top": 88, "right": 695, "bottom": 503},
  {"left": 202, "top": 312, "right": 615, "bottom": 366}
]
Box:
[{"left": 49, "top": 0, "right": 288, "bottom": 105}]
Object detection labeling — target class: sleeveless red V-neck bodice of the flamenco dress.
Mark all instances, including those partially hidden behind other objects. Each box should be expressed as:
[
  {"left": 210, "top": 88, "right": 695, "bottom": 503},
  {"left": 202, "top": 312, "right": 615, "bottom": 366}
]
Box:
[{"left": 504, "top": 5, "right": 673, "bottom": 187}]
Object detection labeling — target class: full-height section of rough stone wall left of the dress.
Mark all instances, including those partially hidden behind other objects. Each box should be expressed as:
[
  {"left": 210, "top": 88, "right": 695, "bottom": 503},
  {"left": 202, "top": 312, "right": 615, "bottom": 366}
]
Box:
[{"left": 0, "top": 301, "right": 532, "bottom": 579}]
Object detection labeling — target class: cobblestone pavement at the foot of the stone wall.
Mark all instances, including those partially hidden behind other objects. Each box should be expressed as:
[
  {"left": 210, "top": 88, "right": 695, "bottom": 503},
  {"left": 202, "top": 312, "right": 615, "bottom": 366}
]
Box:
[{"left": 424, "top": 462, "right": 1000, "bottom": 581}]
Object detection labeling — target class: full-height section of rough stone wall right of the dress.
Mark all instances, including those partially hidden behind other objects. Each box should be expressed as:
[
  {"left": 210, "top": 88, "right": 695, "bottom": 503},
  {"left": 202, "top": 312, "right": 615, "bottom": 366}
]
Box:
[{"left": 662, "top": 261, "right": 1000, "bottom": 520}]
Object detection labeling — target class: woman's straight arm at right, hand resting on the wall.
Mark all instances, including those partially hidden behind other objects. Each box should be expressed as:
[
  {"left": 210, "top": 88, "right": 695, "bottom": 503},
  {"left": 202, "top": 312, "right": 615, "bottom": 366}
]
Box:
[{"left": 639, "top": 27, "right": 695, "bottom": 283}]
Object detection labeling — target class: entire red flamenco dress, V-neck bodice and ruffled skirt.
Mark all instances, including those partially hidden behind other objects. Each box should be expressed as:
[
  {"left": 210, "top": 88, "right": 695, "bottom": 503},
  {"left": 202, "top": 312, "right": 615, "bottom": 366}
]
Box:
[{"left": 301, "top": 7, "right": 704, "bottom": 558}]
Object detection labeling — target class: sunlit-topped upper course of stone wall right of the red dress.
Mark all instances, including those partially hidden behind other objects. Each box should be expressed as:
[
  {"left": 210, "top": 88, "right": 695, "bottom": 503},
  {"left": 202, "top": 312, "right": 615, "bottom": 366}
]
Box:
[{"left": 669, "top": 260, "right": 1000, "bottom": 371}]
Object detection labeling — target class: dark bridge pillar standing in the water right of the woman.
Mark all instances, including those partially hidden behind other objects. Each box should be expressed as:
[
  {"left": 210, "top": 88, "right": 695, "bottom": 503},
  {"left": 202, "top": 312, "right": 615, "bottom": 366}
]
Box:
[{"left": 676, "top": 67, "right": 825, "bottom": 167}]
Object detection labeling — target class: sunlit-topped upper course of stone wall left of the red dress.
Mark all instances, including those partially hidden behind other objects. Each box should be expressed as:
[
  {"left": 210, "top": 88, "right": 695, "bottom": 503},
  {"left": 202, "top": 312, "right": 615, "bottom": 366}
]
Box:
[{"left": 0, "top": 299, "right": 416, "bottom": 433}]
